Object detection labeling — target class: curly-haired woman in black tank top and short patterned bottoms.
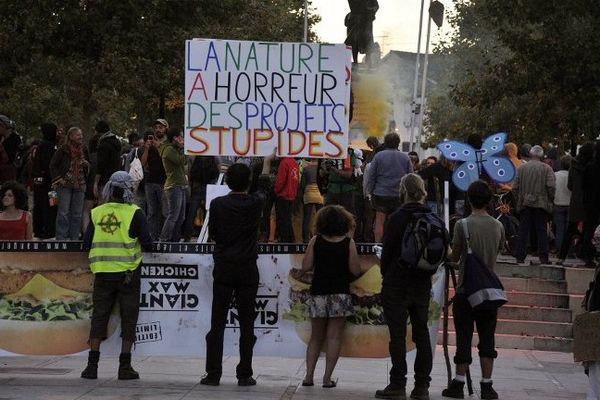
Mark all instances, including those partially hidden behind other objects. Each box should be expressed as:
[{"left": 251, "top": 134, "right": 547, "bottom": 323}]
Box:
[{"left": 294, "top": 206, "right": 360, "bottom": 388}]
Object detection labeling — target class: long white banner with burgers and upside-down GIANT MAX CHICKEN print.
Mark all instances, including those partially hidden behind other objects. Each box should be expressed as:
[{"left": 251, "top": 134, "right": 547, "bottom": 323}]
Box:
[{"left": 0, "top": 241, "right": 444, "bottom": 357}]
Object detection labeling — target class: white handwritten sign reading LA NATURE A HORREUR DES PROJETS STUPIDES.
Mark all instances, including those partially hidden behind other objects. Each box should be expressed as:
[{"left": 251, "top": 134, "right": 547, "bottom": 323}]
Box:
[{"left": 185, "top": 39, "right": 351, "bottom": 158}]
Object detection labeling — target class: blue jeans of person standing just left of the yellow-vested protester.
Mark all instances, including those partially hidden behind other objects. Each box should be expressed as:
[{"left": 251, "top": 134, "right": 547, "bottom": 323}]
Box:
[{"left": 56, "top": 186, "right": 85, "bottom": 240}]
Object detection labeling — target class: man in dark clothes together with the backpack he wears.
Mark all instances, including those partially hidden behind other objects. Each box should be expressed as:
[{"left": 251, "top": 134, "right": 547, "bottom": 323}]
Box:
[{"left": 375, "top": 173, "right": 448, "bottom": 400}]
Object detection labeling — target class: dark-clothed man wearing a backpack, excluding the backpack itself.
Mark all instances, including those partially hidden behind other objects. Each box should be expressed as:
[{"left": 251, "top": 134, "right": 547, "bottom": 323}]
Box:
[{"left": 375, "top": 173, "right": 440, "bottom": 399}]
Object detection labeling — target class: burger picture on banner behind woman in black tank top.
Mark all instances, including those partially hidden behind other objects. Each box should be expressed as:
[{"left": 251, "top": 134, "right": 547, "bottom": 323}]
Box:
[{"left": 283, "top": 256, "right": 440, "bottom": 358}]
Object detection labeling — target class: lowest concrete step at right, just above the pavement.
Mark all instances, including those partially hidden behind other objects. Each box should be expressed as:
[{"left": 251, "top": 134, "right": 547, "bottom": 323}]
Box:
[{"left": 438, "top": 331, "right": 573, "bottom": 356}]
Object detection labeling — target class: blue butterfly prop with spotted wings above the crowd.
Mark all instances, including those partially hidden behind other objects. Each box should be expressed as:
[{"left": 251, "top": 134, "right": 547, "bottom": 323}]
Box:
[{"left": 436, "top": 132, "right": 516, "bottom": 192}]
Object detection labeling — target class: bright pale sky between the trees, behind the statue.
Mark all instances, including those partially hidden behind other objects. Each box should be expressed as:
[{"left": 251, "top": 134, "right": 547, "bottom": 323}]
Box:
[{"left": 312, "top": 0, "right": 452, "bottom": 56}]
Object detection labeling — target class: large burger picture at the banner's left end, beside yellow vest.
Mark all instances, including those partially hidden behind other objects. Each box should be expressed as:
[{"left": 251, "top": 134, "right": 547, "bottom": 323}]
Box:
[{"left": 0, "top": 252, "right": 117, "bottom": 355}]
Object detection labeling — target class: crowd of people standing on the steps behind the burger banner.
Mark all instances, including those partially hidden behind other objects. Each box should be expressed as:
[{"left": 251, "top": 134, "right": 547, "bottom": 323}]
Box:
[{"left": 0, "top": 115, "right": 600, "bottom": 266}]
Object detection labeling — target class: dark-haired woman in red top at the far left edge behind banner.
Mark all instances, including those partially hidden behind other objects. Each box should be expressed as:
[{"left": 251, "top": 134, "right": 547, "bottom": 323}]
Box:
[{"left": 0, "top": 181, "right": 33, "bottom": 240}]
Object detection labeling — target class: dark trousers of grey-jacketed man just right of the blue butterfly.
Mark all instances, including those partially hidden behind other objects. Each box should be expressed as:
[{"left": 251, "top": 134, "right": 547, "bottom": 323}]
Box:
[{"left": 517, "top": 207, "right": 548, "bottom": 262}]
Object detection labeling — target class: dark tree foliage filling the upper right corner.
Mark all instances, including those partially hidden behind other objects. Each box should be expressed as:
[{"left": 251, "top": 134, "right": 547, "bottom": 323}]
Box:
[{"left": 427, "top": 0, "right": 600, "bottom": 150}]
